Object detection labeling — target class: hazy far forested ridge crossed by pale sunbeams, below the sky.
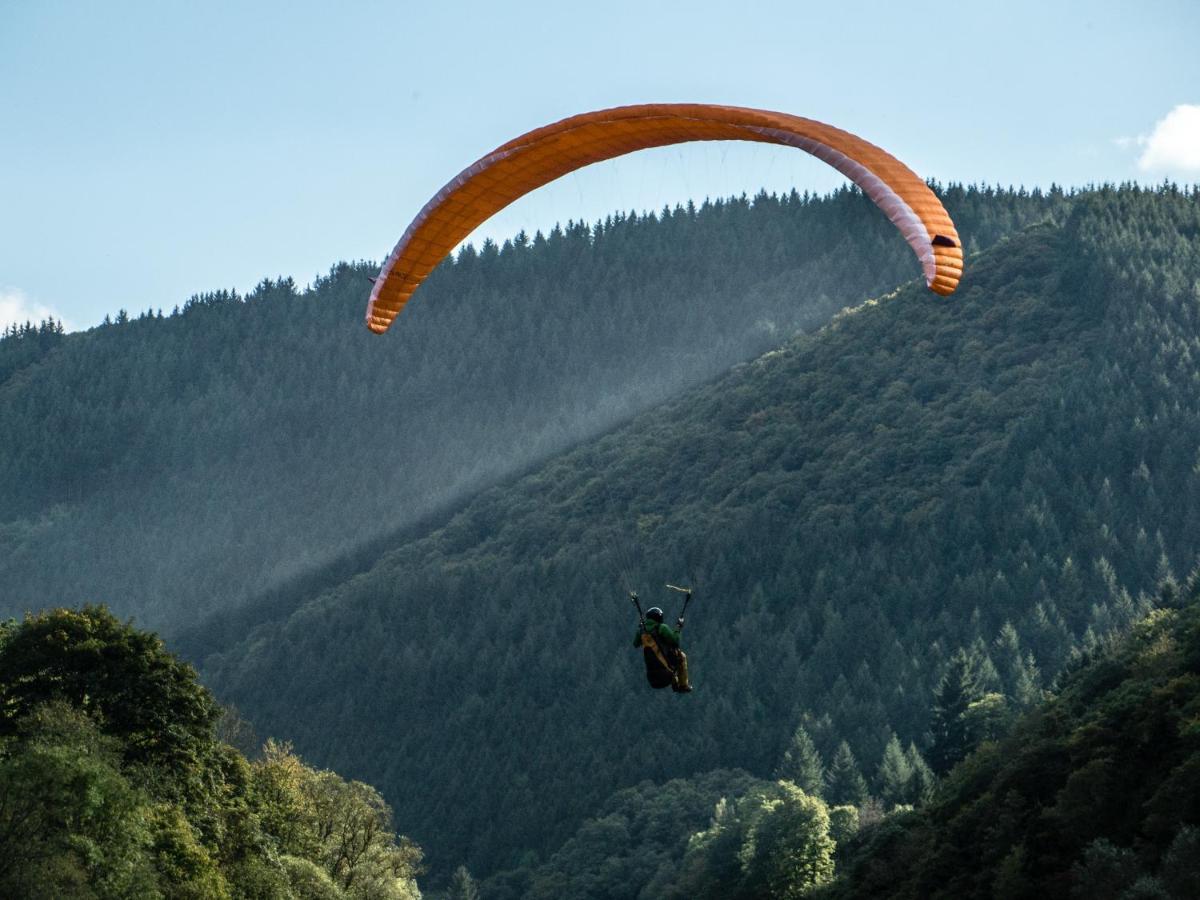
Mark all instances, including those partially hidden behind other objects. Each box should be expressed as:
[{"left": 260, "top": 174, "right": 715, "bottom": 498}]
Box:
[{"left": 0, "top": 187, "right": 1066, "bottom": 635}]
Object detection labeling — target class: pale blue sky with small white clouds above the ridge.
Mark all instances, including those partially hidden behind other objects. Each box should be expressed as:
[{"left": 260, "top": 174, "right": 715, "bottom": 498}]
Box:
[{"left": 0, "top": 0, "right": 1200, "bottom": 329}]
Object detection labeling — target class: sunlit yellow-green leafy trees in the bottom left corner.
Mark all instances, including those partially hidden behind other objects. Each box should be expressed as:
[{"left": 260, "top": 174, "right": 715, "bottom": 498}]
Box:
[{"left": 0, "top": 607, "right": 421, "bottom": 900}]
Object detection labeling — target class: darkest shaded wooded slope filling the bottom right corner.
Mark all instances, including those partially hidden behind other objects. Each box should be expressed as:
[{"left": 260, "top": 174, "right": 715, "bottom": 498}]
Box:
[{"left": 828, "top": 600, "right": 1200, "bottom": 900}]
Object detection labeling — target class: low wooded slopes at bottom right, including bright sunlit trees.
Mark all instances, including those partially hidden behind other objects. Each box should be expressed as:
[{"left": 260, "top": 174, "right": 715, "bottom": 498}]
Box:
[{"left": 516, "top": 592, "right": 1200, "bottom": 900}]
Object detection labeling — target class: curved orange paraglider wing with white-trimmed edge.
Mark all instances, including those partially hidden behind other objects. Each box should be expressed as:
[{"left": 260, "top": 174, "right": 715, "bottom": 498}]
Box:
[{"left": 366, "top": 103, "right": 962, "bottom": 334}]
